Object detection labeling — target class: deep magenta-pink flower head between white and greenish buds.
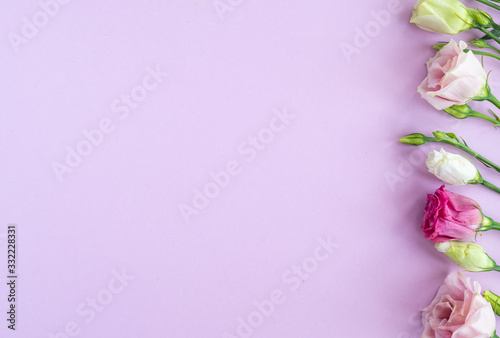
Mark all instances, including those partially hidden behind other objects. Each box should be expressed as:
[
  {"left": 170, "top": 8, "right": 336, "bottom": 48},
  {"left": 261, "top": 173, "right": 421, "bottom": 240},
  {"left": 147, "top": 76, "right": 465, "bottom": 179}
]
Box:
[{"left": 422, "top": 185, "right": 483, "bottom": 243}]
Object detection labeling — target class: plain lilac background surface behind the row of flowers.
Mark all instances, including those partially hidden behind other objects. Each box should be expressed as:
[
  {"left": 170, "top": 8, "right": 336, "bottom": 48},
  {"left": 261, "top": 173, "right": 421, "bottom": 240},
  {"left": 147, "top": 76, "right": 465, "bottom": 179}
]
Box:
[{"left": 0, "top": 0, "right": 500, "bottom": 338}]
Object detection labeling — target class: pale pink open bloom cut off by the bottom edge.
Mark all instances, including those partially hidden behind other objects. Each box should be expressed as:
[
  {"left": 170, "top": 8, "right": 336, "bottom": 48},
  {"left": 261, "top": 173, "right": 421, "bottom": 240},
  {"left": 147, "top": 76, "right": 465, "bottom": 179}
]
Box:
[{"left": 422, "top": 271, "right": 496, "bottom": 338}]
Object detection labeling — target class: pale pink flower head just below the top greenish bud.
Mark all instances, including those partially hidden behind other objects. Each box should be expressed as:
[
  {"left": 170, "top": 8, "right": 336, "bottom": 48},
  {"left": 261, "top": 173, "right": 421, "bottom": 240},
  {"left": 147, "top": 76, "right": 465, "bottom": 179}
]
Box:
[{"left": 418, "top": 40, "right": 487, "bottom": 110}]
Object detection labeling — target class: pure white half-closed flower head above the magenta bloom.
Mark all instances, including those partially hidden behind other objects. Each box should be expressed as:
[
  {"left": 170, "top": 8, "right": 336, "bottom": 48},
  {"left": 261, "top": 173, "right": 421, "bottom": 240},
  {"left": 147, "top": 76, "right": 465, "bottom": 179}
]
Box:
[{"left": 425, "top": 148, "right": 480, "bottom": 185}]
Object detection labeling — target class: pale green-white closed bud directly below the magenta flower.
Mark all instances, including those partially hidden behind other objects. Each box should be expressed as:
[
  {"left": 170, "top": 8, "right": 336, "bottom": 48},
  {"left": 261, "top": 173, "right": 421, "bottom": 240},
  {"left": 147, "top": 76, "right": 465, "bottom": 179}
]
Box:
[{"left": 435, "top": 241, "right": 497, "bottom": 272}]
